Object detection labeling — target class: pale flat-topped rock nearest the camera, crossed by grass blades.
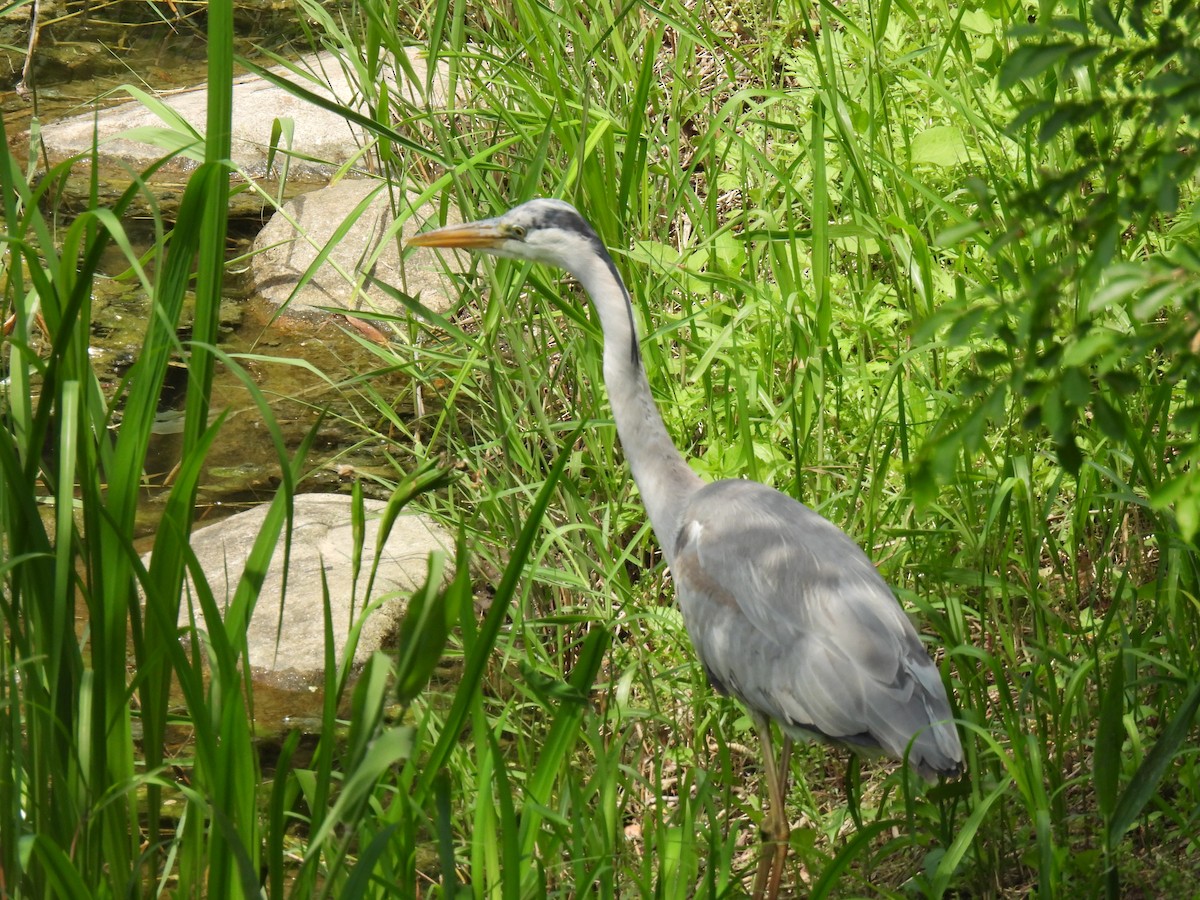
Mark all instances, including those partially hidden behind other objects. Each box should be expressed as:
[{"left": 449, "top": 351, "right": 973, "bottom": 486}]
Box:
[{"left": 154, "top": 494, "right": 455, "bottom": 689}]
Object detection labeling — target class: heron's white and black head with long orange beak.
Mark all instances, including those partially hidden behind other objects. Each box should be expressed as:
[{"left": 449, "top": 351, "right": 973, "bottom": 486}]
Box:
[{"left": 408, "top": 199, "right": 608, "bottom": 275}]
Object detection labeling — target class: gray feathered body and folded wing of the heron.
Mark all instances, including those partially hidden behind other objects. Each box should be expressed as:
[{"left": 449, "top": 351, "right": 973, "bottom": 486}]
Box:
[{"left": 672, "top": 481, "right": 962, "bottom": 776}]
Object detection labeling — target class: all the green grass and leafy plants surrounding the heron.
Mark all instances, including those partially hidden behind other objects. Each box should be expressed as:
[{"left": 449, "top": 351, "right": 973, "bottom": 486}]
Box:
[{"left": 0, "top": 0, "right": 1200, "bottom": 898}]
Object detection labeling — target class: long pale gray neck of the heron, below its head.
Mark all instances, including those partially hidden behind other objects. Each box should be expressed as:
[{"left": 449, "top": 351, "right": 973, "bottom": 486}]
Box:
[{"left": 572, "top": 256, "right": 703, "bottom": 564}]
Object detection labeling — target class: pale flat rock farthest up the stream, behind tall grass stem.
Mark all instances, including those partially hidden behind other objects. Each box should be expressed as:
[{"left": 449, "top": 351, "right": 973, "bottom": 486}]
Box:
[{"left": 34, "top": 48, "right": 449, "bottom": 182}]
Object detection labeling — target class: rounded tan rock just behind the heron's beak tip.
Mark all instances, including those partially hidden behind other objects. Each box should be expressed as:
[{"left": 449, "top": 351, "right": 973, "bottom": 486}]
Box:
[{"left": 251, "top": 179, "right": 467, "bottom": 316}]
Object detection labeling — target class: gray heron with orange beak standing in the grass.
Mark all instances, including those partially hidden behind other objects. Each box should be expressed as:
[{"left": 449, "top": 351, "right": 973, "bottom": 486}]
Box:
[{"left": 408, "top": 199, "right": 962, "bottom": 898}]
